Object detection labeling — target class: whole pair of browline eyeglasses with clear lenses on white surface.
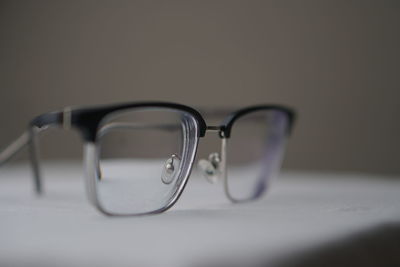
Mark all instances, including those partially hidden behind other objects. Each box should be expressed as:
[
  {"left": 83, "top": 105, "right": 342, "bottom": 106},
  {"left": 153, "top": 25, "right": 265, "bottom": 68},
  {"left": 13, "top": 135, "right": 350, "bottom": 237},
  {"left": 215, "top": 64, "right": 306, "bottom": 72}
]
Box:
[{"left": 0, "top": 102, "right": 295, "bottom": 215}]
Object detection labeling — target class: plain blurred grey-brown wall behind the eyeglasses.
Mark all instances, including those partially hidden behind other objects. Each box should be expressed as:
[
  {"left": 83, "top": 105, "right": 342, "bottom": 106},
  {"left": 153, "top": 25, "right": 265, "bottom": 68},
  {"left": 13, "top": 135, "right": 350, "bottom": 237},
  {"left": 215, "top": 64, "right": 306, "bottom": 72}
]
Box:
[{"left": 0, "top": 1, "right": 400, "bottom": 174}]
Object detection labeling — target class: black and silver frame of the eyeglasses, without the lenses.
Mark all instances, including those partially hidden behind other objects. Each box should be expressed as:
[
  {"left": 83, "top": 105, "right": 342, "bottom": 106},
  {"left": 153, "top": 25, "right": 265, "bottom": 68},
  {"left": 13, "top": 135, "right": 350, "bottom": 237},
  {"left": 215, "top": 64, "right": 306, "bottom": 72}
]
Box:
[{"left": 0, "top": 102, "right": 296, "bottom": 216}]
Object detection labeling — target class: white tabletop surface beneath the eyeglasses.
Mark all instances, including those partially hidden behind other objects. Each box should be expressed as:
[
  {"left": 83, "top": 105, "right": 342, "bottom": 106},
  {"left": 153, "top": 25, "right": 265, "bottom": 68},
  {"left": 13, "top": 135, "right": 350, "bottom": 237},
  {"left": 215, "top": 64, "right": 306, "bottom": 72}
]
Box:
[{"left": 0, "top": 162, "right": 400, "bottom": 266}]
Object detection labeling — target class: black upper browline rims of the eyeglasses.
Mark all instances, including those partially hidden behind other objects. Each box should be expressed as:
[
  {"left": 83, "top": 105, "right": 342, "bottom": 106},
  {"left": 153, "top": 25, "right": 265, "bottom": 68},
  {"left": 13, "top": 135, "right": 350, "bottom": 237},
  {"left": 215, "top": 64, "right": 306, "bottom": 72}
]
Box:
[{"left": 30, "top": 102, "right": 295, "bottom": 142}]
